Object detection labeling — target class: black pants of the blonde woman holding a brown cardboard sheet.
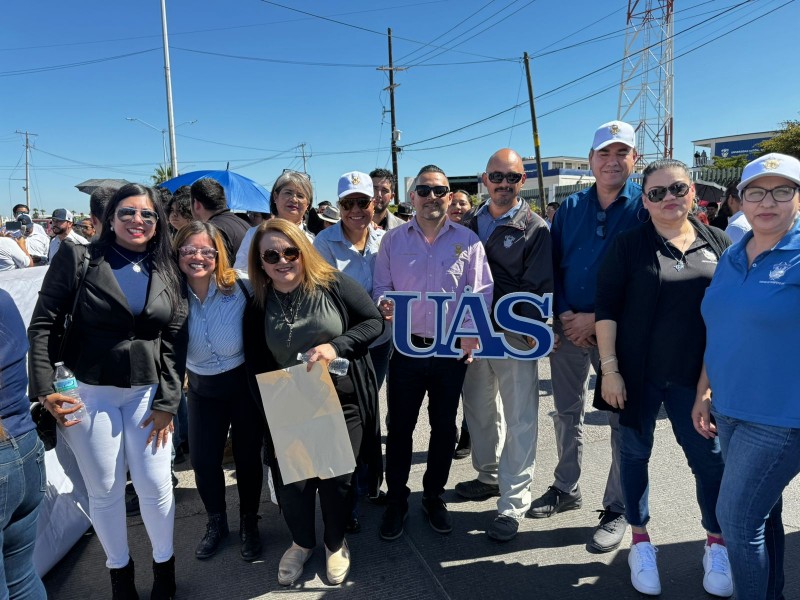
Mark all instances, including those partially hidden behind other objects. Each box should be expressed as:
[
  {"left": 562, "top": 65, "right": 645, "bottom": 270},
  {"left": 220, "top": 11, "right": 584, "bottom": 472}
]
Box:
[{"left": 277, "top": 394, "right": 363, "bottom": 552}]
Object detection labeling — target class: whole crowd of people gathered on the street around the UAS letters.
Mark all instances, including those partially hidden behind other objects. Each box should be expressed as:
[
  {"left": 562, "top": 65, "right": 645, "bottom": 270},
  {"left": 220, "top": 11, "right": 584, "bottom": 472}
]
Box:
[{"left": 0, "top": 121, "right": 800, "bottom": 600}]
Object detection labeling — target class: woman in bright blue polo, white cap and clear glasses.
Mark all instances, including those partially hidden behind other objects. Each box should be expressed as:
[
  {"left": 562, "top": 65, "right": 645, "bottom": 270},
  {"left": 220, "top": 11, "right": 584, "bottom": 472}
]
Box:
[{"left": 692, "top": 154, "right": 800, "bottom": 600}]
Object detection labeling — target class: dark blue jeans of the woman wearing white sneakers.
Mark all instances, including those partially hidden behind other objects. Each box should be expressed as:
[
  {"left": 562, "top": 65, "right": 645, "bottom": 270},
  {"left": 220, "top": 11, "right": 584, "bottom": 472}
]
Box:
[{"left": 620, "top": 382, "right": 724, "bottom": 533}]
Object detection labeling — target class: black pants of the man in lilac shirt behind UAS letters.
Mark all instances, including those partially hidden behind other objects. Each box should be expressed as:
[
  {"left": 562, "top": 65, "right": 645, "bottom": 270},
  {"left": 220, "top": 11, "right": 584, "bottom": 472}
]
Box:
[{"left": 386, "top": 352, "right": 467, "bottom": 504}]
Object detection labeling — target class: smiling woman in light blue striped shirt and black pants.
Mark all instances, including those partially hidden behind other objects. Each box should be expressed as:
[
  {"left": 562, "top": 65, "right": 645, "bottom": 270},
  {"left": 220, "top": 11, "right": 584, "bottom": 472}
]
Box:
[{"left": 174, "top": 221, "right": 264, "bottom": 562}]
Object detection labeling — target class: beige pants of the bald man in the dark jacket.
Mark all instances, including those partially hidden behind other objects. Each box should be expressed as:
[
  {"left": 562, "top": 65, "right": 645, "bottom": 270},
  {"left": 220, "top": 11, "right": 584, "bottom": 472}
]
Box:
[{"left": 463, "top": 334, "right": 539, "bottom": 519}]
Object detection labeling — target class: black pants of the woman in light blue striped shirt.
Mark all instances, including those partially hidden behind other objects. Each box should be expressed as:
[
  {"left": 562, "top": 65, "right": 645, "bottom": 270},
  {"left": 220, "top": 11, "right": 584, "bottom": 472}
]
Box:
[{"left": 189, "top": 366, "right": 264, "bottom": 515}]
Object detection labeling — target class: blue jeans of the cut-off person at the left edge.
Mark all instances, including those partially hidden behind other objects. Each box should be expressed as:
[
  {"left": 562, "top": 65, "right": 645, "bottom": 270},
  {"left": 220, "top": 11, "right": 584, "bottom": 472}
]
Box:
[{"left": 0, "top": 429, "right": 47, "bottom": 600}]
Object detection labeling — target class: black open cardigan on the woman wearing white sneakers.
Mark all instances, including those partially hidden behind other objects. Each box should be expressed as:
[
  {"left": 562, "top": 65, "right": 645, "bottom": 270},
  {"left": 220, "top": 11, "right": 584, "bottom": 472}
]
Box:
[{"left": 593, "top": 216, "right": 731, "bottom": 429}]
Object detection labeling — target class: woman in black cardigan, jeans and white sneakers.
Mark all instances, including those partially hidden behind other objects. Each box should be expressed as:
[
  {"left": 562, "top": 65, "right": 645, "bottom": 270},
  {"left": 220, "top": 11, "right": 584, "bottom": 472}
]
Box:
[{"left": 595, "top": 160, "right": 733, "bottom": 597}]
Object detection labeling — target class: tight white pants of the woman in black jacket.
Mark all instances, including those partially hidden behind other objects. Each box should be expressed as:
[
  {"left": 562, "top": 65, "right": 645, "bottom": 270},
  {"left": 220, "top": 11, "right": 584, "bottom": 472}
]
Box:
[{"left": 62, "top": 383, "right": 175, "bottom": 569}]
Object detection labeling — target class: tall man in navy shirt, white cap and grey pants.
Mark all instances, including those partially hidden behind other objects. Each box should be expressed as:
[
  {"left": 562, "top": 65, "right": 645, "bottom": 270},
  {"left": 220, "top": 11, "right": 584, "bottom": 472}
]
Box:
[{"left": 528, "top": 121, "right": 645, "bottom": 552}]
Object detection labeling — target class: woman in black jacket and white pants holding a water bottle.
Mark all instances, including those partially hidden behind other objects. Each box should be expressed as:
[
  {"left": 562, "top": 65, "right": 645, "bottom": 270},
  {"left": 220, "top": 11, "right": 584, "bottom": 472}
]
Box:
[{"left": 28, "top": 183, "right": 187, "bottom": 599}]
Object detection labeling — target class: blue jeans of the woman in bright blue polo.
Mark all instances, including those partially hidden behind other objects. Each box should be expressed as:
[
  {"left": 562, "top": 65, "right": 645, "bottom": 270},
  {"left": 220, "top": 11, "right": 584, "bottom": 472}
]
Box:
[{"left": 714, "top": 414, "right": 800, "bottom": 600}]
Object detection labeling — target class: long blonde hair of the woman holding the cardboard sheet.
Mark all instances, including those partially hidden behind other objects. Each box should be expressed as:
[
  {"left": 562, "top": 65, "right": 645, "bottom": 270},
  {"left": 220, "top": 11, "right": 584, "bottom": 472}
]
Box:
[{"left": 247, "top": 218, "right": 337, "bottom": 308}]
